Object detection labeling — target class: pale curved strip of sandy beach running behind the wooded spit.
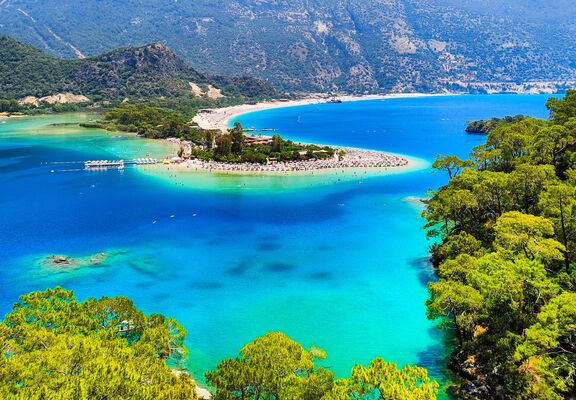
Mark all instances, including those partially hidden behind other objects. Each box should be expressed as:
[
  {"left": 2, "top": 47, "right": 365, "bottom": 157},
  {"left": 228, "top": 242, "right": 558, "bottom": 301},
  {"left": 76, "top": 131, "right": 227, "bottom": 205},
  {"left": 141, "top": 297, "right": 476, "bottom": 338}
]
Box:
[{"left": 192, "top": 93, "right": 454, "bottom": 131}]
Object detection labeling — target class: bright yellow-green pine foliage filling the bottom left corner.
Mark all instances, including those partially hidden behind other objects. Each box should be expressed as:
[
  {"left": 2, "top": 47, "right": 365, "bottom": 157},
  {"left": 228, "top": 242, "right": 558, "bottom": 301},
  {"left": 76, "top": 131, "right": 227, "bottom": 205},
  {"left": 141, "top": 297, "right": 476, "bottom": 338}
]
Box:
[{"left": 0, "top": 288, "right": 196, "bottom": 400}]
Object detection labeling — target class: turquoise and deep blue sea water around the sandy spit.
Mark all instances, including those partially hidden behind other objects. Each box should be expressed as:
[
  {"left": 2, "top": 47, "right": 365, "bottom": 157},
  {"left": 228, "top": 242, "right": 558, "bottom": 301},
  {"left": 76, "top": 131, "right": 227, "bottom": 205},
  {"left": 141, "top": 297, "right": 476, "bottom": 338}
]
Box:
[{"left": 0, "top": 95, "right": 560, "bottom": 392}]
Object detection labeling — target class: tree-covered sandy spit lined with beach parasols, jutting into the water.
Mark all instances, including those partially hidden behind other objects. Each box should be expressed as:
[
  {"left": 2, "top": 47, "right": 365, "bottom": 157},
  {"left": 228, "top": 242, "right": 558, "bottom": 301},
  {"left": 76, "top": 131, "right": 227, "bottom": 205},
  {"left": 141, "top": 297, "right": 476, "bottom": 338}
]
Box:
[{"left": 80, "top": 99, "right": 409, "bottom": 173}]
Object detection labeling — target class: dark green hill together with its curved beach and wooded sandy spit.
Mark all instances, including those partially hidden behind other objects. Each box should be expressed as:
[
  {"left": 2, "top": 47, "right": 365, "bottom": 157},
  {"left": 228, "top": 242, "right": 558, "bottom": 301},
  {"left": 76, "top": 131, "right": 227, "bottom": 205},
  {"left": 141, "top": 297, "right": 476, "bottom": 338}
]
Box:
[{"left": 0, "top": 37, "right": 425, "bottom": 177}]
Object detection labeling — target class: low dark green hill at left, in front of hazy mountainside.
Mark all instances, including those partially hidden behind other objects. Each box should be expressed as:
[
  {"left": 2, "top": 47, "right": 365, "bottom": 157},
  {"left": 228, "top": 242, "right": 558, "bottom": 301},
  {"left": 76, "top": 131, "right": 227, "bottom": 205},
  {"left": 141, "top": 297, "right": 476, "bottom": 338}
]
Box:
[{"left": 0, "top": 37, "right": 276, "bottom": 101}]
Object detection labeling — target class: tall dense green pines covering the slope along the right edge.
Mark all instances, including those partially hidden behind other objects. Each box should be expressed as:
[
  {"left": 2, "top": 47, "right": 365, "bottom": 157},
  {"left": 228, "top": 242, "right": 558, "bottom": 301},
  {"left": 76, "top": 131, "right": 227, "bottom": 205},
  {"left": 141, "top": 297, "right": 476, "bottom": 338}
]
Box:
[{"left": 423, "top": 91, "right": 576, "bottom": 399}]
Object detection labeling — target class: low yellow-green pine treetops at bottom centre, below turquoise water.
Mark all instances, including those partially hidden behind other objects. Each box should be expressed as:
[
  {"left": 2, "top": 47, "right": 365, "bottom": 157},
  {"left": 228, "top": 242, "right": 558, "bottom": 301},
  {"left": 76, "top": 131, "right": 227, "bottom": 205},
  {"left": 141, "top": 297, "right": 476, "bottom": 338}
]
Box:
[{"left": 206, "top": 332, "right": 438, "bottom": 400}]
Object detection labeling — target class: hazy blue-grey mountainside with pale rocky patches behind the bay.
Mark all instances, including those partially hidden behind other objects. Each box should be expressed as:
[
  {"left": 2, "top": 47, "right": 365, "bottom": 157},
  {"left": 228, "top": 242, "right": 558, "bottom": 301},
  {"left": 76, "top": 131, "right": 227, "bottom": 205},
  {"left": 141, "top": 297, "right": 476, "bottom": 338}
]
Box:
[{"left": 0, "top": 0, "right": 576, "bottom": 92}]
